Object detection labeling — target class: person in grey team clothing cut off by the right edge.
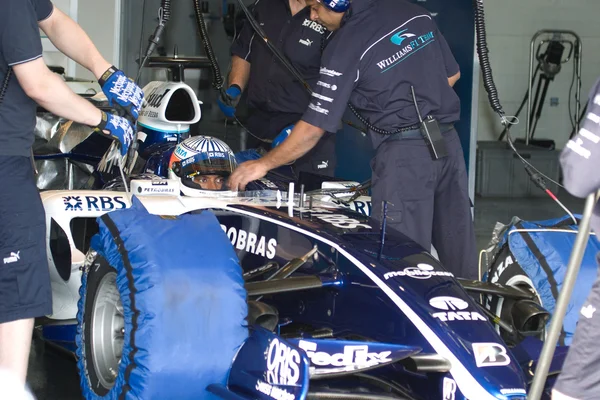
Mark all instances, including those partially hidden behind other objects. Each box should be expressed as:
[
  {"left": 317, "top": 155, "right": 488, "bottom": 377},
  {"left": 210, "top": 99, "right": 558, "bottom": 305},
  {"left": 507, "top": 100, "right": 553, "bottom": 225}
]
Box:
[{"left": 552, "top": 79, "right": 600, "bottom": 400}]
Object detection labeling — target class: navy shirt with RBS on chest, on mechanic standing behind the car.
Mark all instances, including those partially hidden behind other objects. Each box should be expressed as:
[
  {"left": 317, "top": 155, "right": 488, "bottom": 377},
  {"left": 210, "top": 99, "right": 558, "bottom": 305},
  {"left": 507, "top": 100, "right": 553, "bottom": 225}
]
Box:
[{"left": 231, "top": 0, "right": 329, "bottom": 115}]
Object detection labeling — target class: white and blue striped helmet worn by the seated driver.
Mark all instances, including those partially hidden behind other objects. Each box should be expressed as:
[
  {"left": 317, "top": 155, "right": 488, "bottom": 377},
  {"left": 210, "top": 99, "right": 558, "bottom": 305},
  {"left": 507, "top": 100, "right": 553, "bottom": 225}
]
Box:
[{"left": 169, "top": 136, "right": 237, "bottom": 197}]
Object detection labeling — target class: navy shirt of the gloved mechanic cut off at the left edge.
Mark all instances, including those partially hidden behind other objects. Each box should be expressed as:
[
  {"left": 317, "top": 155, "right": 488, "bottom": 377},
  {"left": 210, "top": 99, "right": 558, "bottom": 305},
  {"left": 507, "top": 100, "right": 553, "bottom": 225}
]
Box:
[{"left": 0, "top": 0, "right": 54, "bottom": 157}]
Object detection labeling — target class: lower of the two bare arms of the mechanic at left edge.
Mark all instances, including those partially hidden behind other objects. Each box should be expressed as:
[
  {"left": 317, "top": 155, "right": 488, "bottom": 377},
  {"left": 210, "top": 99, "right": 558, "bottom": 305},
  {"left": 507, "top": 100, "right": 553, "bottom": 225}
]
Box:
[{"left": 13, "top": 58, "right": 102, "bottom": 126}]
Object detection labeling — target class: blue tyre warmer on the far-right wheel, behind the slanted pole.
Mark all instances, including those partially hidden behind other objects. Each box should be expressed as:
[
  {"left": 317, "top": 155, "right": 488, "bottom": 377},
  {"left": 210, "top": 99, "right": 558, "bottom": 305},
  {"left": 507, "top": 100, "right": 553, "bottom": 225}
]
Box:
[{"left": 498, "top": 215, "right": 600, "bottom": 346}]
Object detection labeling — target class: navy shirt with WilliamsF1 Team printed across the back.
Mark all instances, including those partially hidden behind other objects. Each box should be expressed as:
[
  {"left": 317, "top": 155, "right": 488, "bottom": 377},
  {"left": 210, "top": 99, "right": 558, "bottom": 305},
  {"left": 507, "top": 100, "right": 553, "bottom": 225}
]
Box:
[{"left": 302, "top": 0, "right": 460, "bottom": 147}]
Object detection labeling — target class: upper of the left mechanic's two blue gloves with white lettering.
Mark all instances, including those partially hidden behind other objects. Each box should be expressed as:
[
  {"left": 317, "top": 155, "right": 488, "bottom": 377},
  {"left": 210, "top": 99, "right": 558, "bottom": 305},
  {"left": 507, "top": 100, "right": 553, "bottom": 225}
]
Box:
[{"left": 98, "top": 65, "right": 144, "bottom": 121}]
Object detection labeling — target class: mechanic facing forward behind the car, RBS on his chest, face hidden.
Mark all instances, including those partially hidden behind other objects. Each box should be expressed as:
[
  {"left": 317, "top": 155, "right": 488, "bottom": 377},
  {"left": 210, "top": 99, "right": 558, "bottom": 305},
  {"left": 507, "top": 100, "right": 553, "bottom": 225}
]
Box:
[{"left": 218, "top": 0, "right": 337, "bottom": 177}]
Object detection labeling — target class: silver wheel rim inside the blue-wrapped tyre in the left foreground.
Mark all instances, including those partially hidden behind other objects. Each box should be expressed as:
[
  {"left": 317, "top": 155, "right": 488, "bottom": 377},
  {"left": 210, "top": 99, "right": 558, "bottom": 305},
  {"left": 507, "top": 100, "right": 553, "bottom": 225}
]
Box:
[{"left": 90, "top": 272, "right": 125, "bottom": 390}]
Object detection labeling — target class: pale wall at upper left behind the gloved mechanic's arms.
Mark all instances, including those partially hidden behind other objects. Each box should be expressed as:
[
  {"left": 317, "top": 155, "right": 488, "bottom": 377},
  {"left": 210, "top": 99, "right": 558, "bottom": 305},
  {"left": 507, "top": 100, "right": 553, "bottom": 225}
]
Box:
[{"left": 43, "top": 0, "right": 121, "bottom": 80}]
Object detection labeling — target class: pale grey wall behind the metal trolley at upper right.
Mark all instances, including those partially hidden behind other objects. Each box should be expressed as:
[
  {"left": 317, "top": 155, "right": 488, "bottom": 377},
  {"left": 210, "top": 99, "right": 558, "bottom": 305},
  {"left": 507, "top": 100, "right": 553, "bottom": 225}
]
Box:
[{"left": 477, "top": 0, "right": 600, "bottom": 148}]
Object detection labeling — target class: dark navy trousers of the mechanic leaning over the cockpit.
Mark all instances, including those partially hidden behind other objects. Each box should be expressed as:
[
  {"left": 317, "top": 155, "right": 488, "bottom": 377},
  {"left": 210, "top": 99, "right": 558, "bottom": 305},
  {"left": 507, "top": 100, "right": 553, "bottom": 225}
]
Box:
[{"left": 371, "top": 128, "right": 478, "bottom": 279}]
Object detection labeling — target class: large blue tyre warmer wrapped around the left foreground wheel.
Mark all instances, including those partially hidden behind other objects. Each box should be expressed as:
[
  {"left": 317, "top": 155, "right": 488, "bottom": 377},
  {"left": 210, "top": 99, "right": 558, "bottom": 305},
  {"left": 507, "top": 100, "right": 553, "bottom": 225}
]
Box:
[{"left": 76, "top": 197, "right": 248, "bottom": 400}]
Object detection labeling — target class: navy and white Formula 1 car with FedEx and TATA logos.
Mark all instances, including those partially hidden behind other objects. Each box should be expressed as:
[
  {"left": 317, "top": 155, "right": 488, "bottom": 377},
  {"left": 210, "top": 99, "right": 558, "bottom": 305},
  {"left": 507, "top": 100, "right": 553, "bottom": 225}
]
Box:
[{"left": 31, "top": 73, "right": 565, "bottom": 400}]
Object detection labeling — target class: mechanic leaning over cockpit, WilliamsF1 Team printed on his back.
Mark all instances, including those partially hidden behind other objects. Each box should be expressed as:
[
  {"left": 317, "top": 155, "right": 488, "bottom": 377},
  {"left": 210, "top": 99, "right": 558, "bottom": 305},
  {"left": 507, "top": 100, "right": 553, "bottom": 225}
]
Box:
[{"left": 229, "top": 0, "right": 477, "bottom": 279}]
